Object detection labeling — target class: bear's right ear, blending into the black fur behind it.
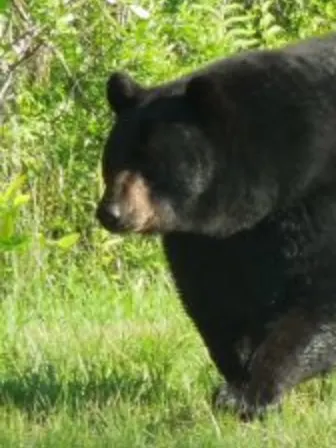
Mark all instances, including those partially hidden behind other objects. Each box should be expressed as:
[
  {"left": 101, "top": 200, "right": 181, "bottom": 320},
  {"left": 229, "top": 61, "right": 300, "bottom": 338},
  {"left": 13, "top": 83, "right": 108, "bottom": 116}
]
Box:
[{"left": 185, "top": 74, "right": 232, "bottom": 116}]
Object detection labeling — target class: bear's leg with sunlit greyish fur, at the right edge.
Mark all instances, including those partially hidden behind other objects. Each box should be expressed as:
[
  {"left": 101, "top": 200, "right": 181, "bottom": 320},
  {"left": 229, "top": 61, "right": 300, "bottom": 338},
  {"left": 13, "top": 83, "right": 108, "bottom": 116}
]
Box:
[{"left": 239, "top": 305, "right": 336, "bottom": 420}]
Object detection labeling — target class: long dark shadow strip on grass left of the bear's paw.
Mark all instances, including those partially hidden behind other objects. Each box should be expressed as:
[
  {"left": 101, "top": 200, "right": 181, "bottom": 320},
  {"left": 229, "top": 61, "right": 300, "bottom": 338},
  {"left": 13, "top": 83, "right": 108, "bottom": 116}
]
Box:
[{"left": 0, "top": 365, "right": 192, "bottom": 417}]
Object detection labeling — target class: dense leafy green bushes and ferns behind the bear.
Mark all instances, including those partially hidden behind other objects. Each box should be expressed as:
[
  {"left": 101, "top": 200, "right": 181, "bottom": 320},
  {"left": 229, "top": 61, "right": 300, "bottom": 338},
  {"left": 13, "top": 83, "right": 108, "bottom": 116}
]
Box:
[{"left": 0, "top": 0, "right": 336, "bottom": 280}]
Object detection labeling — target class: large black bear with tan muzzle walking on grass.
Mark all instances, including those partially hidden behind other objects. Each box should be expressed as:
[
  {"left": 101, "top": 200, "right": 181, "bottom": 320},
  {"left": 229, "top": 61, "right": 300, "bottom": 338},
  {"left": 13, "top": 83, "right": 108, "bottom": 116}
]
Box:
[{"left": 97, "top": 34, "right": 336, "bottom": 419}]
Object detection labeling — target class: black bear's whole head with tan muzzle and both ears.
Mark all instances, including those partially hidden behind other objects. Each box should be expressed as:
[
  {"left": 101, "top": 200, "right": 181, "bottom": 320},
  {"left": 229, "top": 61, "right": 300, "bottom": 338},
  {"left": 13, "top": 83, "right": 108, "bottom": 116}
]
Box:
[{"left": 97, "top": 72, "right": 276, "bottom": 236}]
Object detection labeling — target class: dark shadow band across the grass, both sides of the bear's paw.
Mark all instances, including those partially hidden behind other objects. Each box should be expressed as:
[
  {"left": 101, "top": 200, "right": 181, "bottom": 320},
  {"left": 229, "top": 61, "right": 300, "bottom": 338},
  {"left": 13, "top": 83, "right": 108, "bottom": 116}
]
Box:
[{"left": 0, "top": 364, "right": 336, "bottom": 417}]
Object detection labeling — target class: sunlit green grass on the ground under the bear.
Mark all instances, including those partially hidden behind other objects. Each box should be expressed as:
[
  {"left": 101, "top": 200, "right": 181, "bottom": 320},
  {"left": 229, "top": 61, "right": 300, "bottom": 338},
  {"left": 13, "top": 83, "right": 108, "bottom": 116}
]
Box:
[{"left": 0, "top": 254, "right": 336, "bottom": 448}]
